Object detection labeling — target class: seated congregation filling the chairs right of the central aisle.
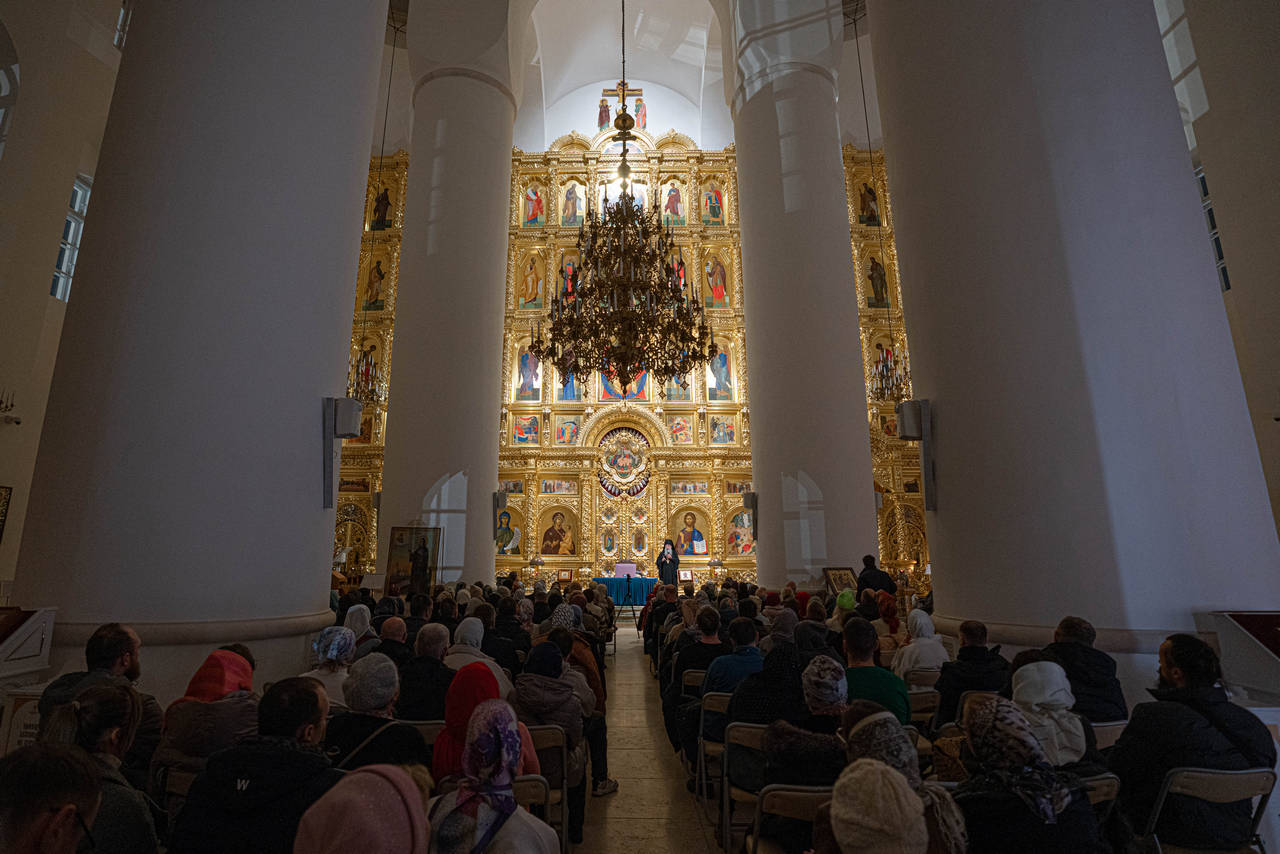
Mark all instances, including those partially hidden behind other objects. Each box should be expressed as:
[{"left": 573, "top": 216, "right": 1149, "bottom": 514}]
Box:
[{"left": 643, "top": 558, "right": 1276, "bottom": 854}]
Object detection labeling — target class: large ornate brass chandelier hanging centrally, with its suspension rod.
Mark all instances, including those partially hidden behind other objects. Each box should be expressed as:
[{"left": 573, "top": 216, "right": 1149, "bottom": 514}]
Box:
[{"left": 529, "top": 0, "right": 718, "bottom": 388}]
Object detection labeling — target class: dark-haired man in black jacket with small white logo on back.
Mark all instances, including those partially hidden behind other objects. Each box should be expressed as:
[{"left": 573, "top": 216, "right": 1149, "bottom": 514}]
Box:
[{"left": 169, "top": 676, "right": 342, "bottom": 854}]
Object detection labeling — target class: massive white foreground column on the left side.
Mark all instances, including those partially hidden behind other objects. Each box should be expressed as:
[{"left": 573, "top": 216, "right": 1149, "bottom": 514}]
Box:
[{"left": 14, "top": 0, "right": 387, "bottom": 698}]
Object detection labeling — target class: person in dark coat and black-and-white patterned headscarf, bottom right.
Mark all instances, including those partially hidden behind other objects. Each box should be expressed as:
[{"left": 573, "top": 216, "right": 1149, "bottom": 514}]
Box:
[{"left": 955, "top": 697, "right": 1111, "bottom": 854}]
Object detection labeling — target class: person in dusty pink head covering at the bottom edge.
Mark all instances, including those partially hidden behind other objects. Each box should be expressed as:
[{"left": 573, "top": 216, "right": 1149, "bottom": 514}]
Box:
[{"left": 293, "top": 764, "right": 430, "bottom": 854}]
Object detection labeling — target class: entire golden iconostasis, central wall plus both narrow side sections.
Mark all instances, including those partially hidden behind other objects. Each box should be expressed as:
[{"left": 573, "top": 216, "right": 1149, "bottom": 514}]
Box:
[{"left": 334, "top": 138, "right": 928, "bottom": 580}]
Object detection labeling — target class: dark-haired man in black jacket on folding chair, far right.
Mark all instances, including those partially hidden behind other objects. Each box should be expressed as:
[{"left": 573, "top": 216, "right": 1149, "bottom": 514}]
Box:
[{"left": 1108, "top": 635, "right": 1276, "bottom": 850}]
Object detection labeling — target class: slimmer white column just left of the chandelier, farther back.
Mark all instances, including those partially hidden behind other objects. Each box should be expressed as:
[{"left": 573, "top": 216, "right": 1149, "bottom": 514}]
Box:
[{"left": 378, "top": 0, "right": 527, "bottom": 581}]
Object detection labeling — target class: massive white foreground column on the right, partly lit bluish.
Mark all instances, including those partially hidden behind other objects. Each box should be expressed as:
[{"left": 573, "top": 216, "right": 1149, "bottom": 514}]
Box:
[{"left": 870, "top": 0, "right": 1280, "bottom": 650}]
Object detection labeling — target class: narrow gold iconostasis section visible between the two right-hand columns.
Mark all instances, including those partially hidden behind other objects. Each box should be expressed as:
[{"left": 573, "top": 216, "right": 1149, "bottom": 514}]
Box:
[{"left": 844, "top": 145, "right": 931, "bottom": 589}]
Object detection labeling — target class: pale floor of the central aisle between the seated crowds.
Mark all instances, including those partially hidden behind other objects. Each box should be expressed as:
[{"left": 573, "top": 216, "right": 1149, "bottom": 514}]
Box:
[{"left": 575, "top": 616, "right": 718, "bottom": 854}]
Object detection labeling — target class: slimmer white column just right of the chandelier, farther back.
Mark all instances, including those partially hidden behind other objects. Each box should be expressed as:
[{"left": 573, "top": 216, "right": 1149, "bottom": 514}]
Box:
[{"left": 732, "top": 0, "right": 878, "bottom": 586}]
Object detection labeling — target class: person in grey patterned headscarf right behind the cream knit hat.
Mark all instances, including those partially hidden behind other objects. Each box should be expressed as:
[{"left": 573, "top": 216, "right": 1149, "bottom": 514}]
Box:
[{"left": 834, "top": 700, "right": 968, "bottom": 854}]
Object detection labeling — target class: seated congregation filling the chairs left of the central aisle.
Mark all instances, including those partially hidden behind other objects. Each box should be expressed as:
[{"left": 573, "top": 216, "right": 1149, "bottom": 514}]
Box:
[{"left": 0, "top": 577, "right": 618, "bottom": 854}]
